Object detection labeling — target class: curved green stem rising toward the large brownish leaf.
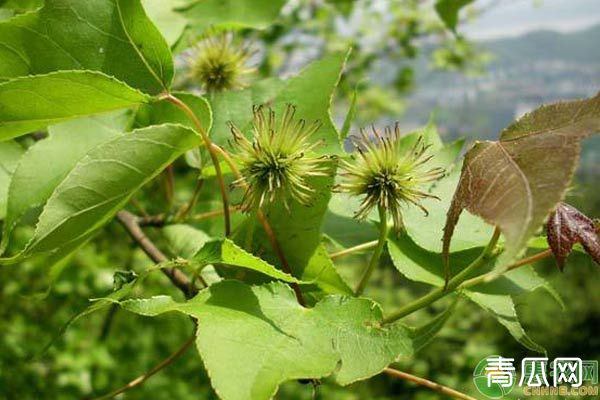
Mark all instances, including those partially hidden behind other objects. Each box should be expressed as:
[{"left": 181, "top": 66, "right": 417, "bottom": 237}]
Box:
[{"left": 383, "top": 228, "right": 500, "bottom": 323}]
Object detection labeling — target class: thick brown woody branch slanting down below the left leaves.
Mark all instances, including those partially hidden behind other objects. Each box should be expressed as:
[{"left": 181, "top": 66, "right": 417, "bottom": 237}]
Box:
[{"left": 117, "top": 210, "right": 197, "bottom": 298}]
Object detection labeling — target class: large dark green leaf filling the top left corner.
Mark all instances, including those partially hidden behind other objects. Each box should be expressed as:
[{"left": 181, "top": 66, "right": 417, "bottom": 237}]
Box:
[{"left": 0, "top": 0, "right": 173, "bottom": 94}]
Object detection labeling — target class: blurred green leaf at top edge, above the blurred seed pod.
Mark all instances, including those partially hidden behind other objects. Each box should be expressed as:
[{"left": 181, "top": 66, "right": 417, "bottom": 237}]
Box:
[{"left": 181, "top": 0, "right": 286, "bottom": 34}]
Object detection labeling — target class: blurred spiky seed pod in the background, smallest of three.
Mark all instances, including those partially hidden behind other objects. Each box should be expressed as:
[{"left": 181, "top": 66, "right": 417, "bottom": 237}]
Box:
[{"left": 189, "top": 33, "right": 254, "bottom": 93}]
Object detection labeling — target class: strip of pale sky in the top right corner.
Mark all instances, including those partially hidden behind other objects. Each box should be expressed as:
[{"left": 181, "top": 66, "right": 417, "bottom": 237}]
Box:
[{"left": 461, "top": 0, "right": 600, "bottom": 40}]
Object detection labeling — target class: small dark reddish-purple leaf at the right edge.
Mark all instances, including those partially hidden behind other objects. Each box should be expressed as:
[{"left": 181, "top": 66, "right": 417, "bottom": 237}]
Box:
[{"left": 547, "top": 203, "right": 600, "bottom": 271}]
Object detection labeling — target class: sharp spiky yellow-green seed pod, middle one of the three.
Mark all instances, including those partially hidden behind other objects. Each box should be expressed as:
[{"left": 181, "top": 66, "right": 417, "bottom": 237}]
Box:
[{"left": 231, "top": 105, "right": 329, "bottom": 211}]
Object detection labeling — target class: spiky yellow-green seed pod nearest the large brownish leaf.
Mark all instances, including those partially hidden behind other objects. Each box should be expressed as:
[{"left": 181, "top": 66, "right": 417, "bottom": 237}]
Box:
[{"left": 336, "top": 124, "right": 444, "bottom": 229}]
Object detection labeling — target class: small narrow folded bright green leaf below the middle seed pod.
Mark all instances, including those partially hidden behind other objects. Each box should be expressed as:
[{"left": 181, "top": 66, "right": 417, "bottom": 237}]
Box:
[{"left": 192, "top": 239, "right": 301, "bottom": 283}]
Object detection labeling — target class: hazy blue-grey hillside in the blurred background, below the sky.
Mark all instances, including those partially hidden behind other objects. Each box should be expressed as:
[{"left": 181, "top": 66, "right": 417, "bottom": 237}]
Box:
[{"left": 405, "top": 25, "right": 600, "bottom": 147}]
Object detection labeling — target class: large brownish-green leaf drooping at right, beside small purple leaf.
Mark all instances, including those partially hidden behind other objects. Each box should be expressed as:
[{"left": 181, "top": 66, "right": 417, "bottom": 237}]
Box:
[{"left": 443, "top": 94, "right": 600, "bottom": 273}]
